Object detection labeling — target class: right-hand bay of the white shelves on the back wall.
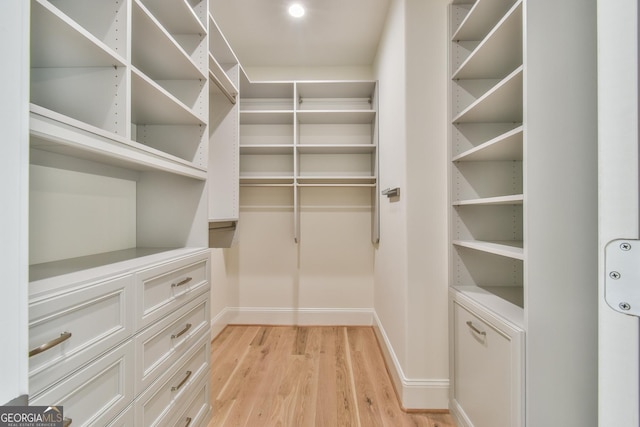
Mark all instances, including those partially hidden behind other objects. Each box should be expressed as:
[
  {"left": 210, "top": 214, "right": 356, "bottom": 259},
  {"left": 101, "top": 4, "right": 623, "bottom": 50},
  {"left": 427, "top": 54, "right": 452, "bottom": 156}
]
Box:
[{"left": 294, "top": 81, "right": 380, "bottom": 244}]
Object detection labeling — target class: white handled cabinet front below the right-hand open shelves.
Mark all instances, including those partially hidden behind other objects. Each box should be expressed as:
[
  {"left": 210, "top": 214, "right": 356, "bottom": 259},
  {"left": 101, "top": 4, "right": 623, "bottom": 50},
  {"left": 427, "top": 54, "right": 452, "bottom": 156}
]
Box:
[{"left": 453, "top": 303, "right": 514, "bottom": 427}]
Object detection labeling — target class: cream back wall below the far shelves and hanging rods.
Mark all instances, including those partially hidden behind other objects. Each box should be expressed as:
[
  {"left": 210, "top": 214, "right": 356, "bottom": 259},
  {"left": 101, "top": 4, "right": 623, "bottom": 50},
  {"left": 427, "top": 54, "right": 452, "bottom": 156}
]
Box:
[{"left": 212, "top": 179, "right": 374, "bottom": 326}]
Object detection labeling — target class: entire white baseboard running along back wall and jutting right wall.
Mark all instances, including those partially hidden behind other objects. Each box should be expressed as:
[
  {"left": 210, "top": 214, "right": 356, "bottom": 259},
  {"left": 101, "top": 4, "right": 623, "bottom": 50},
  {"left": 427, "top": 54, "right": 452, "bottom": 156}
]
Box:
[{"left": 211, "top": 307, "right": 449, "bottom": 410}]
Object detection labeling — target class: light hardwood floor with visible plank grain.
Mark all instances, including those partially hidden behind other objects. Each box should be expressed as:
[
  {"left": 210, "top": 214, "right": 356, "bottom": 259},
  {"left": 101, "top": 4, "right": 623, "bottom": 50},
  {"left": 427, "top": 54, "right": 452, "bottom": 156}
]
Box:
[{"left": 208, "top": 326, "right": 455, "bottom": 427}]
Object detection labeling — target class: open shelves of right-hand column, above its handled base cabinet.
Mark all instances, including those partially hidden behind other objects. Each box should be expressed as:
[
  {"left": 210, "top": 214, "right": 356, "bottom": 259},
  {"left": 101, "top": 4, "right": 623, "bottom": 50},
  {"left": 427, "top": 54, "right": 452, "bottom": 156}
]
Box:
[{"left": 451, "top": 0, "right": 526, "bottom": 314}]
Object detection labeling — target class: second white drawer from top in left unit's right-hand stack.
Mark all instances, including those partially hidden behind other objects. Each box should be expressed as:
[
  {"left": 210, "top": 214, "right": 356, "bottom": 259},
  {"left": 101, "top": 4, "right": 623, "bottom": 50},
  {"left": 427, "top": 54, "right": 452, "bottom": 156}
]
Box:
[{"left": 135, "top": 294, "right": 209, "bottom": 394}]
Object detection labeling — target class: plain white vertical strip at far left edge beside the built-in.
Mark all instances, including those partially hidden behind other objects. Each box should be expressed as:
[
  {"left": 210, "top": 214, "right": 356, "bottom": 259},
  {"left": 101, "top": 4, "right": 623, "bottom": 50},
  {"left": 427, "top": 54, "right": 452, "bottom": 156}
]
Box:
[{"left": 0, "top": 0, "right": 29, "bottom": 405}]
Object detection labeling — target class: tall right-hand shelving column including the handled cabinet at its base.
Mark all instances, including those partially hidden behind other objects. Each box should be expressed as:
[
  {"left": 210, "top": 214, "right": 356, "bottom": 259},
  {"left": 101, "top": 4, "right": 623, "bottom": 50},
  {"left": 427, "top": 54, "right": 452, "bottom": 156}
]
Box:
[{"left": 449, "top": 0, "right": 527, "bottom": 427}]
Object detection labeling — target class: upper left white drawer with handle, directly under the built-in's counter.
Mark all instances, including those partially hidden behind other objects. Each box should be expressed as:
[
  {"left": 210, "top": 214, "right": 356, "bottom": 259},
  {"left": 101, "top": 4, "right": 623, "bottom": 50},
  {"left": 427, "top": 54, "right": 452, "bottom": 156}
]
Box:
[{"left": 29, "top": 275, "right": 134, "bottom": 396}]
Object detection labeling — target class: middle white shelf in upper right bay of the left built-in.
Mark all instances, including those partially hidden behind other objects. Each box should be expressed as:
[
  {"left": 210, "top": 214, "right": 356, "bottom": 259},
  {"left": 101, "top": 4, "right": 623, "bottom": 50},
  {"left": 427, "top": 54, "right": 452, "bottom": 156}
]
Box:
[{"left": 131, "top": 0, "right": 208, "bottom": 81}]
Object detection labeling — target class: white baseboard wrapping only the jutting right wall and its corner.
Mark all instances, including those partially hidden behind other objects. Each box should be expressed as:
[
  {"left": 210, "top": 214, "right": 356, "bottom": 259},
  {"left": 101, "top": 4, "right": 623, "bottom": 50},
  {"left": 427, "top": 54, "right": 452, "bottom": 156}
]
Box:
[{"left": 373, "top": 312, "right": 449, "bottom": 410}]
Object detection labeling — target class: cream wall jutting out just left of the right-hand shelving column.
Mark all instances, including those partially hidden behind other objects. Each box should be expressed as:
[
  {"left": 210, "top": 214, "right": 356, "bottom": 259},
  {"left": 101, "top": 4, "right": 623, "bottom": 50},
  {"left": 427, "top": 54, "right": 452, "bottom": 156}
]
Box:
[{"left": 374, "top": 0, "right": 448, "bottom": 409}]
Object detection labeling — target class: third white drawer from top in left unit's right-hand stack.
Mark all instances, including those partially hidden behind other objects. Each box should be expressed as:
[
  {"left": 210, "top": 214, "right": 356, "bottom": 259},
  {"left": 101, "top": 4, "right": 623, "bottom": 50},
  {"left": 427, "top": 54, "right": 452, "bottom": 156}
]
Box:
[{"left": 135, "top": 335, "right": 211, "bottom": 427}]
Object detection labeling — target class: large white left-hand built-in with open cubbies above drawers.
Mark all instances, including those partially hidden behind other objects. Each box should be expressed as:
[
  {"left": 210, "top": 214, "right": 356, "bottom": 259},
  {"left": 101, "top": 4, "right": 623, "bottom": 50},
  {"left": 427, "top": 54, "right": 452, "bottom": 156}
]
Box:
[{"left": 29, "top": 0, "right": 215, "bottom": 425}]
